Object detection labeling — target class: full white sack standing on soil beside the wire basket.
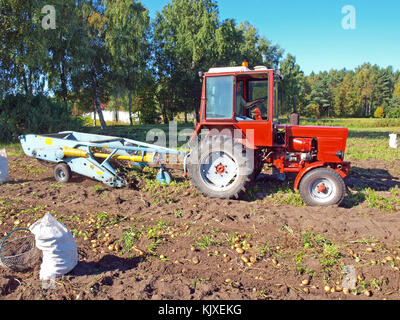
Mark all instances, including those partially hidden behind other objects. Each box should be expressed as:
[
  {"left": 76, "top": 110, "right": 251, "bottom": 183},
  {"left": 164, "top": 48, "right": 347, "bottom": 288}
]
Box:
[{"left": 29, "top": 213, "right": 78, "bottom": 280}]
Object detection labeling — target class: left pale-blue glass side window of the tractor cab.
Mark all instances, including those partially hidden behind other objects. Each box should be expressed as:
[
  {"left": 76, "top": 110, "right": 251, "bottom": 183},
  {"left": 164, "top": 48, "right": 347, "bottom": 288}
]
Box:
[{"left": 206, "top": 76, "right": 234, "bottom": 119}]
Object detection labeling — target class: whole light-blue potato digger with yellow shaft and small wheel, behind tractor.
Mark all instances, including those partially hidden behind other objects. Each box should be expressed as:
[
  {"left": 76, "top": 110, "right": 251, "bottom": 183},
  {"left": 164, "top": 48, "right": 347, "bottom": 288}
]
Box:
[{"left": 19, "top": 131, "right": 182, "bottom": 188}]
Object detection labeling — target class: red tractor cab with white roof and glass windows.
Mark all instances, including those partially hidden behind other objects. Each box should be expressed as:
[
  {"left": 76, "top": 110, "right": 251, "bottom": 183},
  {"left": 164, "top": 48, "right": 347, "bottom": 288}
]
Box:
[{"left": 200, "top": 64, "right": 285, "bottom": 147}]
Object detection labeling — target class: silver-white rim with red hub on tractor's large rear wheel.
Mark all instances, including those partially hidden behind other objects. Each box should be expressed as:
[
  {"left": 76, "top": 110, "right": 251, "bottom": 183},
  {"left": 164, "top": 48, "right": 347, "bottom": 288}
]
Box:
[{"left": 199, "top": 151, "right": 239, "bottom": 192}]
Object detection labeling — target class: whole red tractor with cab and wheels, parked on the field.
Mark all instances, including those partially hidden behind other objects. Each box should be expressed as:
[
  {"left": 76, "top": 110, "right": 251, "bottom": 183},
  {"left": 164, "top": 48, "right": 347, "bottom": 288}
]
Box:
[{"left": 187, "top": 64, "right": 350, "bottom": 206}]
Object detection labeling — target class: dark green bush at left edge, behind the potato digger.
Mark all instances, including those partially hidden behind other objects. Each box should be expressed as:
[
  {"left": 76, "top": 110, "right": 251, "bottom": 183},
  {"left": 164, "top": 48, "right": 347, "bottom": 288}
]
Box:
[{"left": 0, "top": 94, "right": 82, "bottom": 142}]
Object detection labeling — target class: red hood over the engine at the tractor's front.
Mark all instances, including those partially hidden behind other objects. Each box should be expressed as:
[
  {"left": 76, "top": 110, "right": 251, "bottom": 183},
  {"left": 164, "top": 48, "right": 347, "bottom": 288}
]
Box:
[{"left": 285, "top": 125, "right": 349, "bottom": 162}]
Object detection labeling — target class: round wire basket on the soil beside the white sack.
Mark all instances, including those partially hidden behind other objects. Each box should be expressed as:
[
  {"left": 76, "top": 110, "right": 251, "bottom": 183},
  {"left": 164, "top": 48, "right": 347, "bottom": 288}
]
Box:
[{"left": 0, "top": 228, "right": 40, "bottom": 271}]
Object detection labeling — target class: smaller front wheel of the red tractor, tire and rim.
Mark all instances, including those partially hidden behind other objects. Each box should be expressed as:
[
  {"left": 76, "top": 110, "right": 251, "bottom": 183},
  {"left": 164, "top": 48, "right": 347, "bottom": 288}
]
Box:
[{"left": 299, "top": 168, "right": 346, "bottom": 207}]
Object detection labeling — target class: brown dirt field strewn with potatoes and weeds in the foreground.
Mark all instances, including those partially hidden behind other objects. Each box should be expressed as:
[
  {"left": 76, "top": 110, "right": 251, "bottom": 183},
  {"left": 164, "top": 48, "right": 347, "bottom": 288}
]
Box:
[{"left": 0, "top": 155, "right": 400, "bottom": 300}]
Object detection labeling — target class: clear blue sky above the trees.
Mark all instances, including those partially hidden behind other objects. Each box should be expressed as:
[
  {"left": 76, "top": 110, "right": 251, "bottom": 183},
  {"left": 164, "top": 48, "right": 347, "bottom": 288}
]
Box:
[{"left": 142, "top": 0, "right": 400, "bottom": 74}]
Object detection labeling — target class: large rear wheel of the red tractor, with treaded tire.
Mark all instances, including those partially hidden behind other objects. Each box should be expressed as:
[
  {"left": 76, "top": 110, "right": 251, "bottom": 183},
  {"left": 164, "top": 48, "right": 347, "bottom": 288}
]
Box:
[{"left": 188, "top": 135, "right": 254, "bottom": 199}]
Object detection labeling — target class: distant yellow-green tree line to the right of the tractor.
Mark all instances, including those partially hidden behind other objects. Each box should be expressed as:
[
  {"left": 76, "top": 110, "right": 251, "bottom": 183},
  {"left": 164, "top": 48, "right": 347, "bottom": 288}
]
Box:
[{"left": 280, "top": 55, "right": 400, "bottom": 118}]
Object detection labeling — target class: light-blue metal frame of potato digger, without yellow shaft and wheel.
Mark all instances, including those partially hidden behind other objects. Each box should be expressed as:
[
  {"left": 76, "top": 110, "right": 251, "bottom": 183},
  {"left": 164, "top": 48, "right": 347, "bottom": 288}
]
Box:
[{"left": 19, "top": 131, "right": 188, "bottom": 188}]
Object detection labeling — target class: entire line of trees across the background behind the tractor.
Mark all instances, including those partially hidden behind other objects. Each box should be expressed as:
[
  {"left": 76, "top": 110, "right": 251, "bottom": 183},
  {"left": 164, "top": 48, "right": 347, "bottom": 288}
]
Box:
[{"left": 0, "top": 0, "right": 400, "bottom": 133}]
